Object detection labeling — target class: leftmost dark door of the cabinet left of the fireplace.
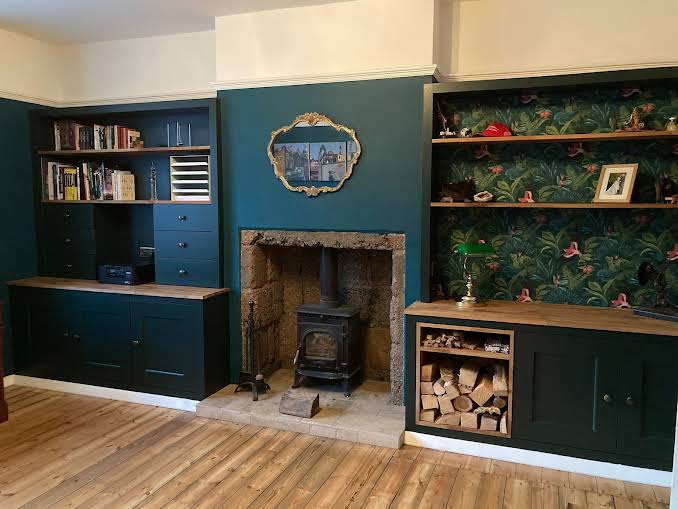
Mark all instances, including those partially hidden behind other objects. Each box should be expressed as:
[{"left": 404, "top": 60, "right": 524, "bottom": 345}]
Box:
[{"left": 21, "top": 290, "right": 74, "bottom": 381}]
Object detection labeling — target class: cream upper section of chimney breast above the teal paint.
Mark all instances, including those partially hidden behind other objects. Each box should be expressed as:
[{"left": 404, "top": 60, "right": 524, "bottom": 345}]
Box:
[{"left": 215, "top": 0, "right": 434, "bottom": 88}]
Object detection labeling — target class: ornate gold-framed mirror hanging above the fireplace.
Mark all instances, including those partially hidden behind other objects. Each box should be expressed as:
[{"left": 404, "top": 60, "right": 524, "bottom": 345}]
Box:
[{"left": 268, "top": 113, "right": 361, "bottom": 196}]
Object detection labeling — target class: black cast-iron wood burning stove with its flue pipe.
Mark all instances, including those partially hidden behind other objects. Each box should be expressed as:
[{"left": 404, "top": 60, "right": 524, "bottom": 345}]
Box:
[{"left": 293, "top": 247, "right": 361, "bottom": 397}]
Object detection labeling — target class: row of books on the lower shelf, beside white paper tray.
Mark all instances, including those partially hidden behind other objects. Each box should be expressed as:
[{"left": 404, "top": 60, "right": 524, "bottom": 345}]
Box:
[{"left": 42, "top": 162, "right": 136, "bottom": 201}]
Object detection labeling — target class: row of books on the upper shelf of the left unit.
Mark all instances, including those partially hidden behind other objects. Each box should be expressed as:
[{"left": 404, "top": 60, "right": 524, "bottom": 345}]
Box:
[{"left": 54, "top": 120, "right": 144, "bottom": 150}]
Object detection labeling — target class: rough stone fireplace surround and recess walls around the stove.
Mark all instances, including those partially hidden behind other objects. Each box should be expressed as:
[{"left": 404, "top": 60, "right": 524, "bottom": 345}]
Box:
[{"left": 240, "top": 230, "right": 405, "bottom": 405}]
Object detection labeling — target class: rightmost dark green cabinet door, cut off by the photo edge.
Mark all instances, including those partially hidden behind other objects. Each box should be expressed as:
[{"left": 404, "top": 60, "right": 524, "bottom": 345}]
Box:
[{"left": 618, "top": 338, "right": 678, "bottom": 465}]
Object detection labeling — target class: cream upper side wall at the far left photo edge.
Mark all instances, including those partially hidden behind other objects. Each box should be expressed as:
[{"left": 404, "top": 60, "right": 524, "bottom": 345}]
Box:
[{"left": 0, "top": 29, "right": 62, "bottom": 105}]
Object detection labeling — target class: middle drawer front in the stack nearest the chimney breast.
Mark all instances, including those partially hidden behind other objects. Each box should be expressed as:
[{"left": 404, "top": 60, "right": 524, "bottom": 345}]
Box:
[{"left": 155, "top": 230, "right": 219, "bottom": 260}]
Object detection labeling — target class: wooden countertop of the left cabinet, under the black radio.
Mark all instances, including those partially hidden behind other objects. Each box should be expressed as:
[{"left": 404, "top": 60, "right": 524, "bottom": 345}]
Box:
[{"left": 7, "top": 277, "right": 229, "bottom": 300}]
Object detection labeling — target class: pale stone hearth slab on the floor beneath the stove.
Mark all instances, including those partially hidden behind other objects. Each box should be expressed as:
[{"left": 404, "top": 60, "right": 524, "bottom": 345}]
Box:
[{"left": 197, "top": 369, "right": 405, "bottom": 448}]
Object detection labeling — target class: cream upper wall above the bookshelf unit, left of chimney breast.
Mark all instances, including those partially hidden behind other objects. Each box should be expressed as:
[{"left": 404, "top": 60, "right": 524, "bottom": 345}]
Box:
[{"left": 62, "top": 31, "right": 215, "bottom": 105}]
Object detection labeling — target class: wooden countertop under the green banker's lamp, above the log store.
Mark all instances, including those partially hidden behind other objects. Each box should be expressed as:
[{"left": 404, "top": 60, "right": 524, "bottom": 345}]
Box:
[{"left": 405, "top": 300, "right": 678, "bottom": 336}]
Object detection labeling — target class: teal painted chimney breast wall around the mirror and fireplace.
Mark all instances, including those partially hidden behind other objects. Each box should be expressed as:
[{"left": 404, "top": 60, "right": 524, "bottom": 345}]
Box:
[{"left": 219, "top": 77, "right": 432, "bottom": 380}]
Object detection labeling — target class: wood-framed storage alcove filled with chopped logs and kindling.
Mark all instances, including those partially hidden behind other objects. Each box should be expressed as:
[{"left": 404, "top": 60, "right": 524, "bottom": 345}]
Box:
[{"left": 416, "top": 322, "right": 514, "bottom": 438}]
